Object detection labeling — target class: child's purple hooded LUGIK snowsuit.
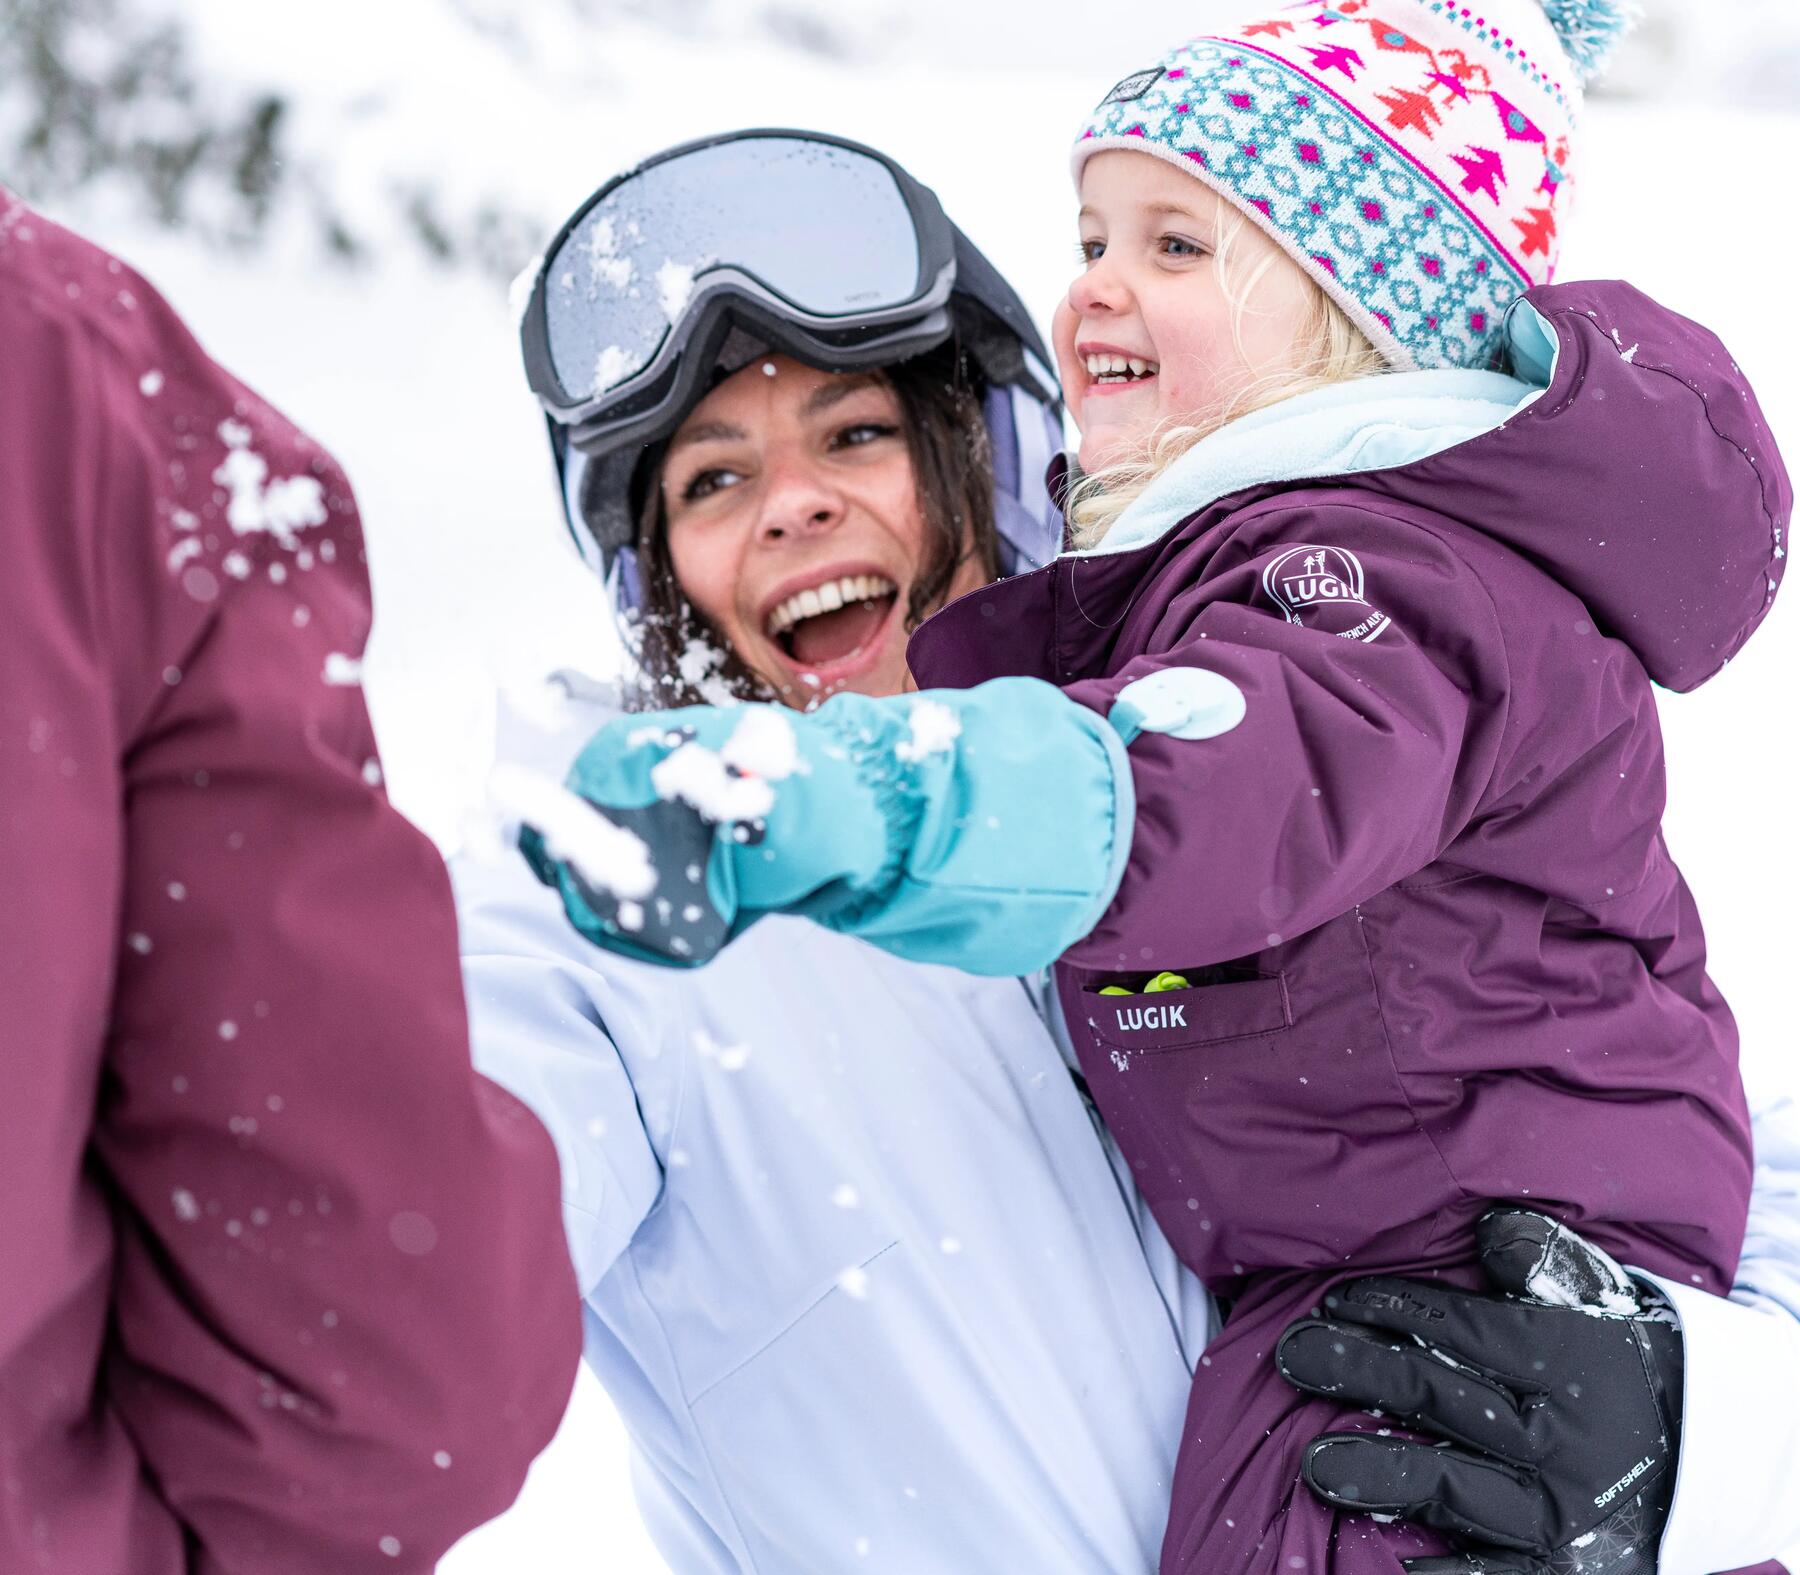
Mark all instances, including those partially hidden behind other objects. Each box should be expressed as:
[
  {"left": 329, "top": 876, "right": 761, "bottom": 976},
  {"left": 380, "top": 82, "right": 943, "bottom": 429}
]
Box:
[{"left": 911, "top": 284, "right": 1793, "bottom": 1575}]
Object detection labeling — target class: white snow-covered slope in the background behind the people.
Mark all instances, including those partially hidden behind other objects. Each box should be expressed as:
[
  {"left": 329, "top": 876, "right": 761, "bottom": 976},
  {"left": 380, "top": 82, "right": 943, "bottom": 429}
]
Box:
[{"left": 28, "top": 0, "right": 1800, "bottom": 1575}]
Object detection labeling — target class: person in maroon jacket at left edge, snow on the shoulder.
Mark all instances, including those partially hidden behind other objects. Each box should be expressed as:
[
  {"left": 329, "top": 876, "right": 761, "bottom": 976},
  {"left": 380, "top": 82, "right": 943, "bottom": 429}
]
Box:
[{"left": 0, "top": 189, "right": 580, "bottom": 1575}]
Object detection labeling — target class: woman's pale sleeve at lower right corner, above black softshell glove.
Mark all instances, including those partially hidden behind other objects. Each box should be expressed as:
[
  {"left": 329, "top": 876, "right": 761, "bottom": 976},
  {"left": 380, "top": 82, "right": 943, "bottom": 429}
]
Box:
[{"left": 1656, "top": 1100, "right": 1800, "bottom": 1575}]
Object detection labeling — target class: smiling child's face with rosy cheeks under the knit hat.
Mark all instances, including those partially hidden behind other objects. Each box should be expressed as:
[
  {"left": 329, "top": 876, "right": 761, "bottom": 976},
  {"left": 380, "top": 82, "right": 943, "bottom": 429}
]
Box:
[{"left": 1055, "top": 149, "right": 1316, "bottom": 472}]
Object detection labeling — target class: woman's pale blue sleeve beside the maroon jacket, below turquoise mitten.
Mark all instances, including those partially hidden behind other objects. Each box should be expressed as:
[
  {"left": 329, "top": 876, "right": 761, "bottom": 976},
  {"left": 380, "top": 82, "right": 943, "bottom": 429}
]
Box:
[{"left": 452, "top": 850, "right": 662, "bottom": 1298}]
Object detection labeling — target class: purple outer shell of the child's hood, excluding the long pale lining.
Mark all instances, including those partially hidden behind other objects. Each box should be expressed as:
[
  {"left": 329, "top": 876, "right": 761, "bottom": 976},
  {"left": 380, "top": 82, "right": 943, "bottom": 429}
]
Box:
[{"left": 1355, "top": 281, "right": 1793, "bottom": 691}]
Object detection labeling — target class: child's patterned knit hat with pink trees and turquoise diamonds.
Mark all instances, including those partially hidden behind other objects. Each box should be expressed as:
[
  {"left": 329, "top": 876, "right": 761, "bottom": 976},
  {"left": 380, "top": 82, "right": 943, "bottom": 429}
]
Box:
[{"left": 1075, "top": 0, "right": 1634, "bottom": 369}]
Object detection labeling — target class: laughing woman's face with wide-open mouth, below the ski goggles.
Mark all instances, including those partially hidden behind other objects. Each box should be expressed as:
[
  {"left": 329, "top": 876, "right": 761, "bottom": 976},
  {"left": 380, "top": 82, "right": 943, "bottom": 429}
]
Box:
[{"left": 661, "top": 355, "right": 981, "bottom": 707}]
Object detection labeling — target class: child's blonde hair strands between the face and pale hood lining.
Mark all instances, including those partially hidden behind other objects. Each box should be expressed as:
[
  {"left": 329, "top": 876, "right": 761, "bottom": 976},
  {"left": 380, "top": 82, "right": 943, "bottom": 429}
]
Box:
[{"left": 1067, "top": 212, "right": 1388, "bottom": 549}]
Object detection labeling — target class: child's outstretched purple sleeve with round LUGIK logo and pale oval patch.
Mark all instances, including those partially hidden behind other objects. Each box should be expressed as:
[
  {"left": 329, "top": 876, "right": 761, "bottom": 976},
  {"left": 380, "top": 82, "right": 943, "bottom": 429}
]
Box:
[{"left": 1064, "top": 499, "right": 1507, "bottom": 968}]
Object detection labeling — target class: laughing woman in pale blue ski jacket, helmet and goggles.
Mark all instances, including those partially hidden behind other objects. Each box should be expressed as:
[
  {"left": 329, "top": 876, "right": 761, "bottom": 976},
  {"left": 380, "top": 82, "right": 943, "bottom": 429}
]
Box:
[{"left": 459, "top": 135, "right": 1800, "bottom": 1571}]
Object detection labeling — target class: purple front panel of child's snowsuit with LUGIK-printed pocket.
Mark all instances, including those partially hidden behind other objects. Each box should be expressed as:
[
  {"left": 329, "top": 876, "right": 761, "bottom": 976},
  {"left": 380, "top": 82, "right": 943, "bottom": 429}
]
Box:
[{"left": 1062, "top": 913, "right": 1447, "bottom": 1289}]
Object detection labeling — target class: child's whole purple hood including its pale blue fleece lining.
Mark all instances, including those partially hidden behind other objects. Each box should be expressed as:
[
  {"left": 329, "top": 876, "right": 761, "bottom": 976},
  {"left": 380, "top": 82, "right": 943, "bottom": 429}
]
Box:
[{"left": 1065, "top": 283, "right": 1793, "bottom": 689}]
